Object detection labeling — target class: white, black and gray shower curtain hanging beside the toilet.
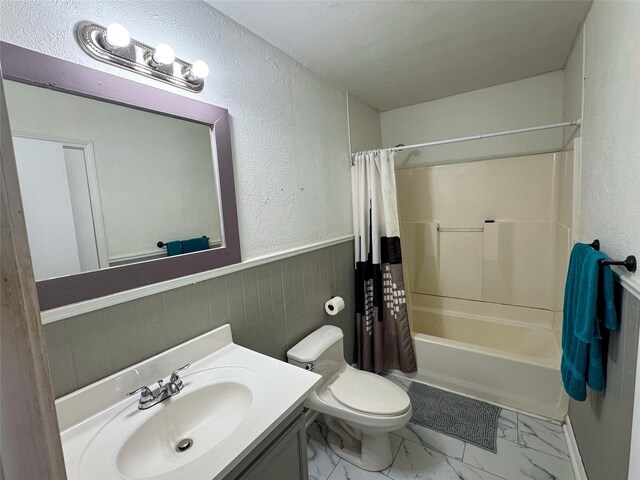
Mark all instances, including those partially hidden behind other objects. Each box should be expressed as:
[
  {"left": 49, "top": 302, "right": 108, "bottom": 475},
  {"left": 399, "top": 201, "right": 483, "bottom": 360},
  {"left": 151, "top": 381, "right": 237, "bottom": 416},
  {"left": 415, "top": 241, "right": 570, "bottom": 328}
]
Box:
[{"left": 351, "top": 150, "right": 416, "bottom": 373}]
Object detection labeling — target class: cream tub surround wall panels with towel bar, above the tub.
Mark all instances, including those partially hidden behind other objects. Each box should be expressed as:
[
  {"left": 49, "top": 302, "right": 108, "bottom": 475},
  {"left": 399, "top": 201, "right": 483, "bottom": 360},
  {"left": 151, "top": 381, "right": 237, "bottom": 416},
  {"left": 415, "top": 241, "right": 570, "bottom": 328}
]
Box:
[{"left": 396, "top": 152, "right": 572, "bottom": 311}]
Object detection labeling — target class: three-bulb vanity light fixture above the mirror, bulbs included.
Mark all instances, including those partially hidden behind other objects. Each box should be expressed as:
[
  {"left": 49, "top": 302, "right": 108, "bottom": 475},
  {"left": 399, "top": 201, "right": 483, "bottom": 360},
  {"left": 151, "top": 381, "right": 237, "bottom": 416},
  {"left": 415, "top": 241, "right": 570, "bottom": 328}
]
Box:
[{"left": 76, "top": 22, "right": 209, "bottom": 92}]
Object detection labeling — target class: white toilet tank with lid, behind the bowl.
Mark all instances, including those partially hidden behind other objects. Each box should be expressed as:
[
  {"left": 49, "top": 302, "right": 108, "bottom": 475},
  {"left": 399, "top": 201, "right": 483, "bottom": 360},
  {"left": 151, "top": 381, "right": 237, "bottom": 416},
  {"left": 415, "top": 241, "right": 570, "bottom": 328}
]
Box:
[{"left": 287, "top": 325, "right": 346, "bottom": 380}]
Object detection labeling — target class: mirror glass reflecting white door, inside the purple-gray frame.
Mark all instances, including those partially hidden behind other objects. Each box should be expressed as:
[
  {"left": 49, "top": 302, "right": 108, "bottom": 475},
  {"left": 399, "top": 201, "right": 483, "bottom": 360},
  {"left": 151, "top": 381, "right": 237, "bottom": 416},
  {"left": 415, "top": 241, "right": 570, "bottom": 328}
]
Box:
[{"left": 5, "top": 80, "right": 222, "bottom": 281}]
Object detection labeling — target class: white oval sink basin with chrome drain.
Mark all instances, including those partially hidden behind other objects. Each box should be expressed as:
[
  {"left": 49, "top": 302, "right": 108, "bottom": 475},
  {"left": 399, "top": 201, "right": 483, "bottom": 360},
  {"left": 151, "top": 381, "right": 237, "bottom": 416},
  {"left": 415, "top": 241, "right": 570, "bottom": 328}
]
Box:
[{"left": 79, "top": 367, "right": 264, "bottom": 479}]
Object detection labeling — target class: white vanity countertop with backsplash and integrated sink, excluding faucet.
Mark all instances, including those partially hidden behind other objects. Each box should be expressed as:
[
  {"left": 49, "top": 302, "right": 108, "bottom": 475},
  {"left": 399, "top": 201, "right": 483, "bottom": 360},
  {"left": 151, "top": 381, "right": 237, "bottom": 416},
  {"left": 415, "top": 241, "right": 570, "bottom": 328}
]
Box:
[{"left": 56, "top": 325, "right": 322, "bottom": 480}]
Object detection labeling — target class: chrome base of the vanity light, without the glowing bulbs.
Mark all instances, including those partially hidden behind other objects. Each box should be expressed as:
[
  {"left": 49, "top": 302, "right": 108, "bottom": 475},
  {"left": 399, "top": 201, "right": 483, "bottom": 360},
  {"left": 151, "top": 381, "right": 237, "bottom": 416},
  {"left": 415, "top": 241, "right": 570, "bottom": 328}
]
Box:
[{"left": 76, "top": 22, "right": 204, "bottom": 93}]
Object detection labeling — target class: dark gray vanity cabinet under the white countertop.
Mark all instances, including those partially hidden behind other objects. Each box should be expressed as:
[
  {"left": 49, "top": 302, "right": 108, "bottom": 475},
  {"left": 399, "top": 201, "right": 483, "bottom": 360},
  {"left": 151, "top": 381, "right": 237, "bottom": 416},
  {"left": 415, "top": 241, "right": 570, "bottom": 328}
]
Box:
[{"left": 225, "top": 407, "right": 308, "bottom": 480}]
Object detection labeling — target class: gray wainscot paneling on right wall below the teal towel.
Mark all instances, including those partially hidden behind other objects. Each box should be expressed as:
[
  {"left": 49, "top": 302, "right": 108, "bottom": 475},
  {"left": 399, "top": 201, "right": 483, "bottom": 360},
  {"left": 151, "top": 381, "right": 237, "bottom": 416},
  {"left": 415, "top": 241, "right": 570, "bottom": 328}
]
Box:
[{"left": 569, "top": 288, "right": 640, "bottom": 480}]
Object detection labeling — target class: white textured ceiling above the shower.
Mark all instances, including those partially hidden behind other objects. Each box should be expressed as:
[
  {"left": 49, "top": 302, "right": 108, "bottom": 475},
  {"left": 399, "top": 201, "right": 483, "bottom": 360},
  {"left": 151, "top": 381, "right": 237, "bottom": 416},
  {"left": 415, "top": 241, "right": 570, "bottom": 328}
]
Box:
[{"left": 206, "top": 0, "right": 591, "bottom": 111}]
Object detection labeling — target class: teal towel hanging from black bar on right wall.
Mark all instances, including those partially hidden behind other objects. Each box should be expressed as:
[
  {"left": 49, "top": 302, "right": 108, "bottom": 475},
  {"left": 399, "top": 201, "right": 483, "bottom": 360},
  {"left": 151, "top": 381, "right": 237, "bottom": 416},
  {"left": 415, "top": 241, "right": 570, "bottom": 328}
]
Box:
[{"left": 560, "top": 243, "right": 618, "bottom": 401}]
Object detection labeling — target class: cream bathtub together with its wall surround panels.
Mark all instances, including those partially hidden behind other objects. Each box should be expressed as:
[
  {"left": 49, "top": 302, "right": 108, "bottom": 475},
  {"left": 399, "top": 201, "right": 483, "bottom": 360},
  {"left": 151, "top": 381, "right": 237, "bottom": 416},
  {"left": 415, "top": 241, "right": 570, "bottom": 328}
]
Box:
[{"left": 396, "top": 150, "right": 573, "bottom": 420}]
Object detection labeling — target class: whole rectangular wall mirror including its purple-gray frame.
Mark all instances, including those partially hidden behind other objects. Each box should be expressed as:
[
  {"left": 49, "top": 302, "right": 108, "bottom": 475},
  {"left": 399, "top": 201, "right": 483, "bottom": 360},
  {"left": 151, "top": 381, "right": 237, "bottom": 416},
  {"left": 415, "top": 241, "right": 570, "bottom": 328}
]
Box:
[{"left": 0, "top": 42, "right": 241, "bottom": 310}]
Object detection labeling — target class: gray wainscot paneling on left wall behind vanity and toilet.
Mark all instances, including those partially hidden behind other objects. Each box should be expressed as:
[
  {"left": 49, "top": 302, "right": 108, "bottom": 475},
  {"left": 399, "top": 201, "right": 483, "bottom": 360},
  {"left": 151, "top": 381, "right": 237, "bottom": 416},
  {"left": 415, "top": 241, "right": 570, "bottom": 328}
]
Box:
[{"left": 44, "top": 241, "right": 355, "bottom": 397}]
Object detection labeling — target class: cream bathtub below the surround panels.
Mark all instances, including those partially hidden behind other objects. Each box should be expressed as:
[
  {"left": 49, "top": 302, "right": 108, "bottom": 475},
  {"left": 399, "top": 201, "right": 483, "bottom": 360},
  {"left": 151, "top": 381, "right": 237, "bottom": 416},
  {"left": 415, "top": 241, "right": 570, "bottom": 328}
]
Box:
[{"left": 400, "top": 294, "right": 568, "bottom": 420}]
